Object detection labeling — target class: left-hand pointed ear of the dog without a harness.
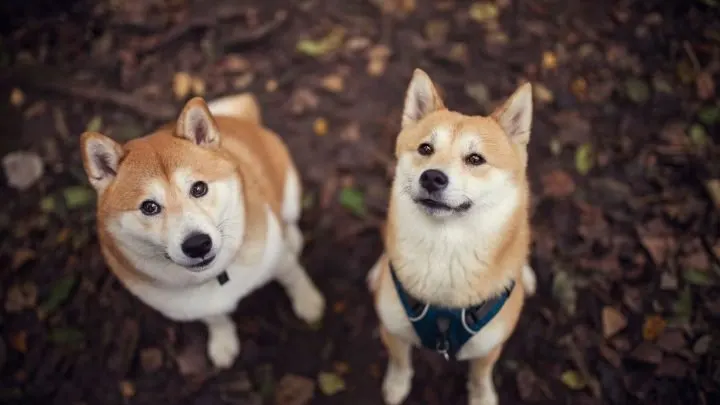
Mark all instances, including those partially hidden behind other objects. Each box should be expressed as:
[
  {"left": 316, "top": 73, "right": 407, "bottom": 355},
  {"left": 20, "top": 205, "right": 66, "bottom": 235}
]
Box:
[{"left": 80, "top": 132, "right": 124, "bottom": 194}]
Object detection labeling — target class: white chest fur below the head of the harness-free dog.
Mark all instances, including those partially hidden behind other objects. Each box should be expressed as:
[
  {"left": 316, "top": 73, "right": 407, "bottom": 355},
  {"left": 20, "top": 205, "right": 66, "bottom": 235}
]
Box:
[{"left": 127, "top": 209, "right": 286, "bottom": 321}]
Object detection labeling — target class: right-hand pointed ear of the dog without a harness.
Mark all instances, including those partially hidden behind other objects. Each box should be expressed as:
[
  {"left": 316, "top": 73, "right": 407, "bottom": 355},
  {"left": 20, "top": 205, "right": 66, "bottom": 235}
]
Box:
[{"left": 175, "top": 97, "right": 220, "bottom": 148}]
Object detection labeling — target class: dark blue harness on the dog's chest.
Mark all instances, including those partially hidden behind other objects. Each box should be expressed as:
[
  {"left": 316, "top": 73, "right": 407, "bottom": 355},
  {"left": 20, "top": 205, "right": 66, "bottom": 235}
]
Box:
[{"left": 390, "top": 264, "right": 515, "bottom": 360}]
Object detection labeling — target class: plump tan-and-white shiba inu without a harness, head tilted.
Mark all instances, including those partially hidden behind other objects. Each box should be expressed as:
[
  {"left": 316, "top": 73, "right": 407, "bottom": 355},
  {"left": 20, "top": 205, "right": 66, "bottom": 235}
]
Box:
[{"left": 81, "top": 94, "right": 325, "bottom": 368}]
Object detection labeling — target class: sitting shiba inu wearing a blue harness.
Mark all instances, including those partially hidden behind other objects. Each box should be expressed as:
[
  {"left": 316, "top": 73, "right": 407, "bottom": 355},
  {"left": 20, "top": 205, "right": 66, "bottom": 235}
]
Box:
[{"left": 368, "top": 69, "right": 536, "bottom": 405}]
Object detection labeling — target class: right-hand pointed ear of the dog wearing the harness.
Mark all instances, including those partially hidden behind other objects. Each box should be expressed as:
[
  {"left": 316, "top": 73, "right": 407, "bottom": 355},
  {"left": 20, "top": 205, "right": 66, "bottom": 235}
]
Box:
[{"left": 492, "top": 83, "right": 532, "bottom": 145}]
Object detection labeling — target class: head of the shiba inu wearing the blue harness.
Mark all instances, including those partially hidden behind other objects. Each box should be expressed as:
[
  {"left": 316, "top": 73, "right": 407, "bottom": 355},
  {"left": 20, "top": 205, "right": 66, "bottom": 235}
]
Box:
[{"left": 393, "top": 69, "right": 532, "bottom": 218}]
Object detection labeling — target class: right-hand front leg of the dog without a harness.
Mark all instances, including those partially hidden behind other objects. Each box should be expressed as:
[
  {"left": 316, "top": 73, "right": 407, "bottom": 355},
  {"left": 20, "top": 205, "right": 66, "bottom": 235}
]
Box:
[{"left": 276, "top": 249, "right": 325, "bottom": 324}]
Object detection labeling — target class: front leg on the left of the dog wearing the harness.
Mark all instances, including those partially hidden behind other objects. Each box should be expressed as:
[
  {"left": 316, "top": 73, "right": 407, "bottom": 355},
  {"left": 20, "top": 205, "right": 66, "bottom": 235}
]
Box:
[{"left": 380, "top": 326, "right": 413, "bottom": 405}]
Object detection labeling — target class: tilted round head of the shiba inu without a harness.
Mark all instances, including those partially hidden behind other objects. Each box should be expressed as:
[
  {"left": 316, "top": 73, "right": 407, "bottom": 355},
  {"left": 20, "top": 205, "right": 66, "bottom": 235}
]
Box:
[{"left": 81, "top": 98, "right": 245, "bottom": 286}]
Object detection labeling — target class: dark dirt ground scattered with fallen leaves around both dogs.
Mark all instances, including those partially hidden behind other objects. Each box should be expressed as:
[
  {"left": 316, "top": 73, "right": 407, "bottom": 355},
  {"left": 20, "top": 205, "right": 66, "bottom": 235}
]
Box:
[{"left": 0, "top": 0, "right": 720, "bottom": 405}]
